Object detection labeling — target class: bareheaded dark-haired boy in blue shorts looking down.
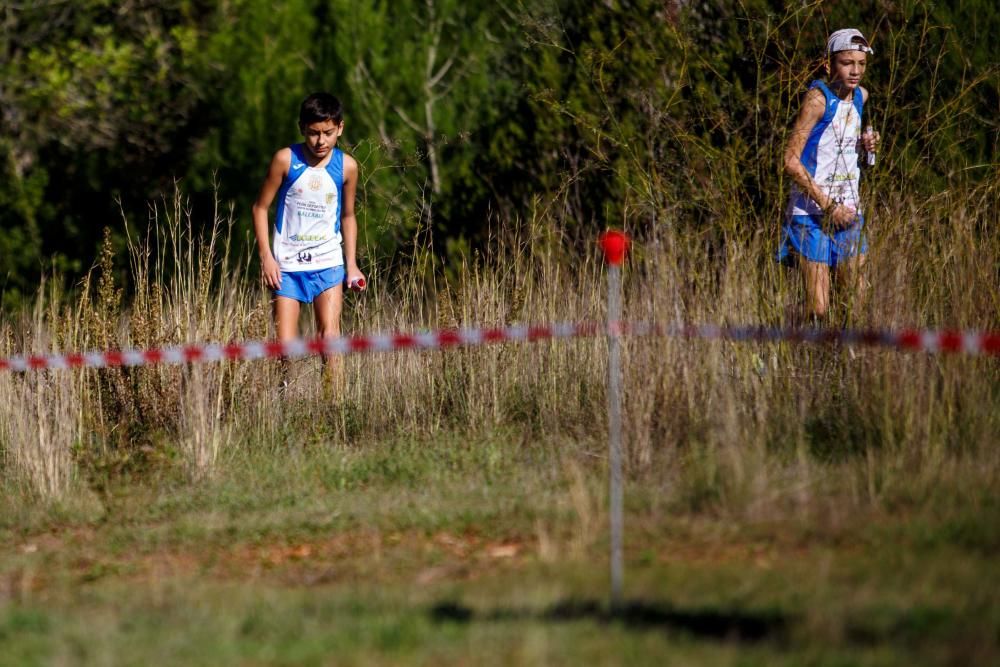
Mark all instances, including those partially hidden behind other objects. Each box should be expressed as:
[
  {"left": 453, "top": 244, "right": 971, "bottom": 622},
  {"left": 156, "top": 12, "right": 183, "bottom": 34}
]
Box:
[{"left": 253, "top": 93, "right": 364, "bottom": 378}]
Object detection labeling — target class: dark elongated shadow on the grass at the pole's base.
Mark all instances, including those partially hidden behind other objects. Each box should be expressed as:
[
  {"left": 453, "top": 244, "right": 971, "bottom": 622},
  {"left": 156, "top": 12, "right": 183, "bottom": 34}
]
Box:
[{"left": 430, "top": 600, "right": 790, "bottom": 642}]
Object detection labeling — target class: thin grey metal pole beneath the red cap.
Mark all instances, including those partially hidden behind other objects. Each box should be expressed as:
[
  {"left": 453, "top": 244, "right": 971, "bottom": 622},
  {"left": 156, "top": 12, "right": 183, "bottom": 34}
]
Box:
[{"left": 608, "top": 264, "right": 624, "bottom": 611}]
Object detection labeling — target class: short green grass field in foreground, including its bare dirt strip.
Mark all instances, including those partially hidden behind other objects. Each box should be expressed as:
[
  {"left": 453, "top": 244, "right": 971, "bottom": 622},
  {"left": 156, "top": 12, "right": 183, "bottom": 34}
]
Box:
[{"left": 0, "top": 418, "right": 1000, "bottom": 665}]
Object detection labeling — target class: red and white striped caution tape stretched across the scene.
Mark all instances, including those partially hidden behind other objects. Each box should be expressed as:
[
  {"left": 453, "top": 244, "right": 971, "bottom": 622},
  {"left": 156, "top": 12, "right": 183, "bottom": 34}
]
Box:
[{"left": 0, "top": 322, "right": 1000, "bottom": 372}]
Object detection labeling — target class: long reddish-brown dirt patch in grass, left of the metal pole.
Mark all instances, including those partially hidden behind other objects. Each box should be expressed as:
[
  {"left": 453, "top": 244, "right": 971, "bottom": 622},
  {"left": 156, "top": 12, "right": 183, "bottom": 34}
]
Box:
[{"left": 0, "top": 529, "right": 533, "bottom": 597}]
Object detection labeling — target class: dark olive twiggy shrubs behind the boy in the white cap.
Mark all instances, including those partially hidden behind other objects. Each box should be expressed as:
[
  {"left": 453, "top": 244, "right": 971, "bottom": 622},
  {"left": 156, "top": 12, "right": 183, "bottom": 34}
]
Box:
[{"left": 497, "top": 0, "right": 998, "bottom": 240}]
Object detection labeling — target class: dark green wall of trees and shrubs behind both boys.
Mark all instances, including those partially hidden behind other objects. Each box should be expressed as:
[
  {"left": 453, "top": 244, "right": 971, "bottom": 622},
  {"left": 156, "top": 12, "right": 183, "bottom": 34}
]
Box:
[{"left": 0, "top": 0, "right": 1000, "bottom": 304}]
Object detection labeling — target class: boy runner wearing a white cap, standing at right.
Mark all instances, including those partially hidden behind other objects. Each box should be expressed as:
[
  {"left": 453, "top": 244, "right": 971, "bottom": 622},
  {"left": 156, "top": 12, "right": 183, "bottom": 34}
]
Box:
[{"left": 778, "top": 28, "right": 879, "bottom": 318}]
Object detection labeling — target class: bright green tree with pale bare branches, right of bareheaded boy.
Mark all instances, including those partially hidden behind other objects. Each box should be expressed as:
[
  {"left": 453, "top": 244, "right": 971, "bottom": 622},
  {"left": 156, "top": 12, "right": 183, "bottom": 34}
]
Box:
[{"left": 330, "top": 0, "right": 513, "bottom": 254}]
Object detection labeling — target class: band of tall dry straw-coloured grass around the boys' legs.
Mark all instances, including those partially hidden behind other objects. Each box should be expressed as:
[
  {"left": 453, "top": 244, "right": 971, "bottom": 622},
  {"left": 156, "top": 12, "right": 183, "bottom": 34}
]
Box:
[{"left": 0, "top": 171, "right": 1000, "bottom": 516}]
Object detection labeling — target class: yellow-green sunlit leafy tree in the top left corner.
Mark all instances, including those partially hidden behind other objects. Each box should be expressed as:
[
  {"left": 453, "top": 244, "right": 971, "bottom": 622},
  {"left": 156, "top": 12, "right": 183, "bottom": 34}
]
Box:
[{"left": 0, "top": 0, "right": 219, "bottom": 302}]
